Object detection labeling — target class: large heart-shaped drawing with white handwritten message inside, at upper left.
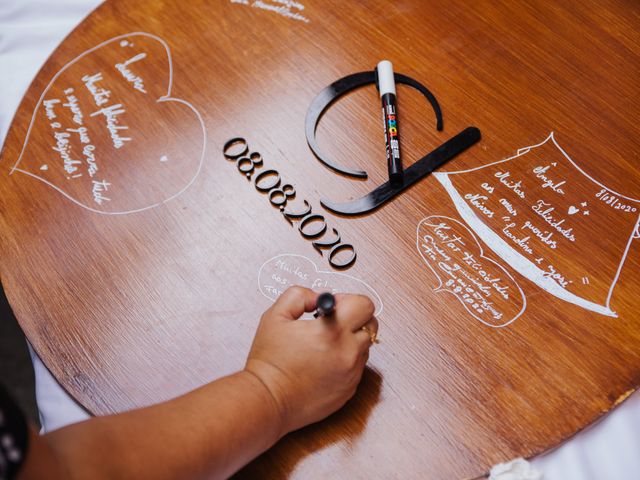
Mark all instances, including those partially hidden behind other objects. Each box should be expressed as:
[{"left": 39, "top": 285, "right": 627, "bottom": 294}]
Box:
[{"left": 10, "top": 32, "right": 207, "bottom": 214}]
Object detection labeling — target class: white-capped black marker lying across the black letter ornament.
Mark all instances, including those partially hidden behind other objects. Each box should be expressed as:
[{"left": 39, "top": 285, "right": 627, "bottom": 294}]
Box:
[{"left": 377, "top": 60, "right": 402, "bottom": 184}]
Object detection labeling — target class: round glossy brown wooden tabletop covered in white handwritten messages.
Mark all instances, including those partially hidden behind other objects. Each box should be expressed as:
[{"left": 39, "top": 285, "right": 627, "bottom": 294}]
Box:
[{"left": 0, "top": 0, "right": 640, "bottom": 479}]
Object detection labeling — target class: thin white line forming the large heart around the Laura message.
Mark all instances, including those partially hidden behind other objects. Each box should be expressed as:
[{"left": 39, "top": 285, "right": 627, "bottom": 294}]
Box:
[{"left": 9, "top": 32, "right": 207, "bottom": 215}]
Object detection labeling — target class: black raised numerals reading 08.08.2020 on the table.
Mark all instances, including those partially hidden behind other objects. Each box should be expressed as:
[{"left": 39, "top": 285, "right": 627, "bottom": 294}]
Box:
[{"left": 223, "top": 137, "right": 357, "bottom": 269}]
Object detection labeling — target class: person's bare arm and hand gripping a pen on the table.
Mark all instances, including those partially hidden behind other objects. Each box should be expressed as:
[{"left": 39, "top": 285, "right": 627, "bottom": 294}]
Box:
[{"left": 19, "top": 287, "right": 378, "bottom": 480}]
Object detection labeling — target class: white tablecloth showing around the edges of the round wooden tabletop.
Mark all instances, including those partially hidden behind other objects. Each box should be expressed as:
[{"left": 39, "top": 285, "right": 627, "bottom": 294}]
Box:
[{"left": 0, "top": 0, "right": 640, "bottom": 480}]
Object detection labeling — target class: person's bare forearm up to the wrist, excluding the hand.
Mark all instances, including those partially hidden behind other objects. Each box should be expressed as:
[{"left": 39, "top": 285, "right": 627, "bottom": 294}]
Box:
[{"left": 35, "top": 371, "right": 285, "bottom": 479}]
